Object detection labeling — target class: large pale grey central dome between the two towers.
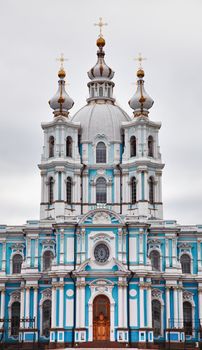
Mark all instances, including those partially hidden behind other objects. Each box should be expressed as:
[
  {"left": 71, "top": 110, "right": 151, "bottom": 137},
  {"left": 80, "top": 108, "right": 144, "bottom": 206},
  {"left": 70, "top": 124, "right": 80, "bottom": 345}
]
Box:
[{"left": 72, "top": 102, "right": 131, "bottom": 142}]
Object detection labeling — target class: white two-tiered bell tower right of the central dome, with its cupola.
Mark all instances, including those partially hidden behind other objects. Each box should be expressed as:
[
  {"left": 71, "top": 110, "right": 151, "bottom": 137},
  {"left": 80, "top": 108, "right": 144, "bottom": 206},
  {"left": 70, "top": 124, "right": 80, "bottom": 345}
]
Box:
[{"left": 122, "top": 57, "right": 164, "bottom": 219}]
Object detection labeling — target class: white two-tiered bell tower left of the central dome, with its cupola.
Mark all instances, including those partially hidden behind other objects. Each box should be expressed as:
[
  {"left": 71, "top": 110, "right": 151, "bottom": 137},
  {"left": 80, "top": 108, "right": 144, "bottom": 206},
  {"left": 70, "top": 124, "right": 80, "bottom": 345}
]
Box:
[{"left": 39, "top": 57, "right": 81, "bottom": 221}]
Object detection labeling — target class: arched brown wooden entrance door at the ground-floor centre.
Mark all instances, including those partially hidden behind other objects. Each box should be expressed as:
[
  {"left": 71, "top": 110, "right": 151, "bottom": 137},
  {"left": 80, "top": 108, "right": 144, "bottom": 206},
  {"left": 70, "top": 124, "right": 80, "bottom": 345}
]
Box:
[{"left": 93, "top": 295, "right": 110, "bottom": 340}]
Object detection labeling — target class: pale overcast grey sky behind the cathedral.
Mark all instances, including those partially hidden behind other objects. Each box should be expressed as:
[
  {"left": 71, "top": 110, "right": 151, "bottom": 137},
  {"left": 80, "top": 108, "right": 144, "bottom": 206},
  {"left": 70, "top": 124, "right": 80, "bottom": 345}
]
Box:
[{"left": 0, "top": 0, "right": 202, "bottom": 225}]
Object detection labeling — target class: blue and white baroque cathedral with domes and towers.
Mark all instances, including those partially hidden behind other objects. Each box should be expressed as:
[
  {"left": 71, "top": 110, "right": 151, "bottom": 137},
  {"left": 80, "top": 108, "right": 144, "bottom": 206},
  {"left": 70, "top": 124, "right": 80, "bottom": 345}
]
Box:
[{"left": 0, "top": 23, "right": 202, "bottom": 349}]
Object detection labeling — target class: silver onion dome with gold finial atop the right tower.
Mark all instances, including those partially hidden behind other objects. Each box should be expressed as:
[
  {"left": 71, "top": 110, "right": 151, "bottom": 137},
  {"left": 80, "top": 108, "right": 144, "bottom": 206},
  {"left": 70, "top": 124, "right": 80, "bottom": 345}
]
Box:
[{"left": 128, "top": 67, "right": 154, "bottom": 117}]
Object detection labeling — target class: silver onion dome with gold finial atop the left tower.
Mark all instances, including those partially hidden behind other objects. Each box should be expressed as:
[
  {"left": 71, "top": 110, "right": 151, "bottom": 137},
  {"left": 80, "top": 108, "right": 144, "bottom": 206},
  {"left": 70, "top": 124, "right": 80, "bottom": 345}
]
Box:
[{"left": 49, "top": 66, "right": 74, "bottom": 117}]
